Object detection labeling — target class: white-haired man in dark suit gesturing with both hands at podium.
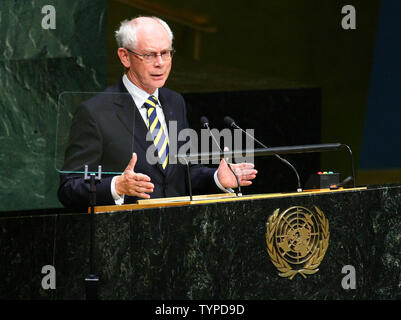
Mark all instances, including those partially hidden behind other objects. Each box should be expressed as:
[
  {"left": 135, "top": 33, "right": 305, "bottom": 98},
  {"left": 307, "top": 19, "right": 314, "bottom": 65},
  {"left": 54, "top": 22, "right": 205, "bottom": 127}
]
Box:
[{"left": 58, "top": 17, "right": 257, "bottom": 208}]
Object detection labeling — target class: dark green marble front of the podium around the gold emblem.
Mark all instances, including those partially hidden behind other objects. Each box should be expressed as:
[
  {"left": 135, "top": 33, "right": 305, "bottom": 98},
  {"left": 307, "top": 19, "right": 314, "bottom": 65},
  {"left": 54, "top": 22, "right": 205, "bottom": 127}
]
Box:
[{"left": 0, "top": 185, "right": 401, "bottom": 300}]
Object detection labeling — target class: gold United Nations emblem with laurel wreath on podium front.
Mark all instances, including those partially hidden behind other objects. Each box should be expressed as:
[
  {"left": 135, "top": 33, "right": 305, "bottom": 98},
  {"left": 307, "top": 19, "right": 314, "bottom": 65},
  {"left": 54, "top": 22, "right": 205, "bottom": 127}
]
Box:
[{"left": 266, "top": 207, "right": 330, "bottom": 280}]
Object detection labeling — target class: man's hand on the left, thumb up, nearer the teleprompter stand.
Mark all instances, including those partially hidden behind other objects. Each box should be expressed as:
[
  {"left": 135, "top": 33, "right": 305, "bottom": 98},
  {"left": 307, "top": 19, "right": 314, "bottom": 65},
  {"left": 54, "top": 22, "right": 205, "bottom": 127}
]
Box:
[{"left": 116, "top": 153, "right": 154, "bottom": 199}]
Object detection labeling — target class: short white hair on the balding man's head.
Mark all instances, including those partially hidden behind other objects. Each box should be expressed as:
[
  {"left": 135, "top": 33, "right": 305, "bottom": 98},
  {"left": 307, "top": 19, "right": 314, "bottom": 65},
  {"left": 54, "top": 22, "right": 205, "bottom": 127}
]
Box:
[{"left": 115, "top": 16, "right": 174, "bottom": 50}]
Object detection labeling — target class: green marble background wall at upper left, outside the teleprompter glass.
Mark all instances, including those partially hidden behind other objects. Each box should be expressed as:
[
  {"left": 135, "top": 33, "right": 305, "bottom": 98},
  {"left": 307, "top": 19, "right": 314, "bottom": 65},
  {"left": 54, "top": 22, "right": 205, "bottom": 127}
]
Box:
[{"left": 0, "top": 0, "right": 107, "bottom": 211}]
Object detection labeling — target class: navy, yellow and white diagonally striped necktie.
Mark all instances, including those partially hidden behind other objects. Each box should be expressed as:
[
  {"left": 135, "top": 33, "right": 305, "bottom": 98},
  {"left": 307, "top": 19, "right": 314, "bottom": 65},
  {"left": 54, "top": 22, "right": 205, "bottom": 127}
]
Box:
[{"left": 144, "top": 96, "right": 169, "bottom": 170}]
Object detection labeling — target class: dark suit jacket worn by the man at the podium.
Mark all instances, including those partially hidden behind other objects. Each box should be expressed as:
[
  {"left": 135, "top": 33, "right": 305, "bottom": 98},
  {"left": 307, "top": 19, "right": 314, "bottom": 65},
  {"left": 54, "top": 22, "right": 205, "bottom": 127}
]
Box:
[{"left": 58, "top": 80, "right": 221, "bottom": 208}]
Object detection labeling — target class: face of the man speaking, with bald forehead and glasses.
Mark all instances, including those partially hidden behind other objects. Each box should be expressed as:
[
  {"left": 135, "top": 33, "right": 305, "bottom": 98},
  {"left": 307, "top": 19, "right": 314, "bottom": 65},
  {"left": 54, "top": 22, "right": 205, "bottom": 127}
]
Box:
[{"left": 120, "top": 21, "right": 172, "bottom": 94}]
